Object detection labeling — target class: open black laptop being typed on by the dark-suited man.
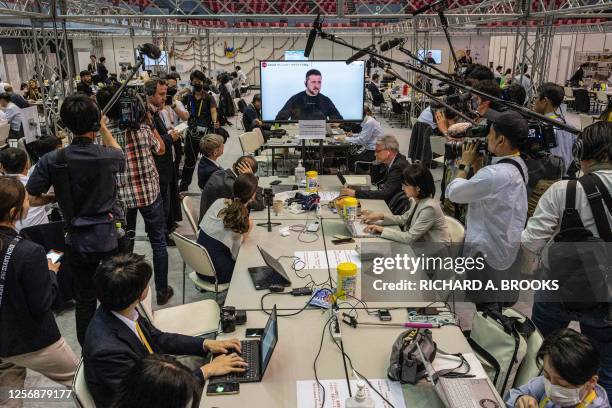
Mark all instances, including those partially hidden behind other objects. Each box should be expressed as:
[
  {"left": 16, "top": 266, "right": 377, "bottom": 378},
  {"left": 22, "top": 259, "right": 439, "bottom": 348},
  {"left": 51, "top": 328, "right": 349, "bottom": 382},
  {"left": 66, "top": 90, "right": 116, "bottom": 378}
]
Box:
[{"left": 215, "top": 305, "right": 278, "bottom": 382}]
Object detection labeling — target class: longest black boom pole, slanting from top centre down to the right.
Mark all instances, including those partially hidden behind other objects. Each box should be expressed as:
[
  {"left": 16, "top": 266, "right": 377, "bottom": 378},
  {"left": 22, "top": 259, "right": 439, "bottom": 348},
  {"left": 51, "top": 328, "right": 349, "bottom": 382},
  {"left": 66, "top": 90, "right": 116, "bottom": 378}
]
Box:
[{"left": 318, "top": 29, "right": 580, "bottom": 134}]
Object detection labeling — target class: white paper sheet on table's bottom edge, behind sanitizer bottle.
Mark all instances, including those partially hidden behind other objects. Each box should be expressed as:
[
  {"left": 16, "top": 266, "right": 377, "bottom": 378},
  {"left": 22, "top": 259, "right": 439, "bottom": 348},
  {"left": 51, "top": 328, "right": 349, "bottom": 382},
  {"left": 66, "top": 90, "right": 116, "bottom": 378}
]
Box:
[{"left": 296, "top": 379, "right": 406, "bottom": 408}]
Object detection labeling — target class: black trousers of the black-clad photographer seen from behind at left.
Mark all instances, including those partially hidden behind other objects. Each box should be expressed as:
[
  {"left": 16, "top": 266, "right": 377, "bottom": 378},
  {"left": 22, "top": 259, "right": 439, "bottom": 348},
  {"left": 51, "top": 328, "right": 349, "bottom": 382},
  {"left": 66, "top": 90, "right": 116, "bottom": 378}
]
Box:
[{"left": 67, "top": 246, "right": 118, "bottom": 346}]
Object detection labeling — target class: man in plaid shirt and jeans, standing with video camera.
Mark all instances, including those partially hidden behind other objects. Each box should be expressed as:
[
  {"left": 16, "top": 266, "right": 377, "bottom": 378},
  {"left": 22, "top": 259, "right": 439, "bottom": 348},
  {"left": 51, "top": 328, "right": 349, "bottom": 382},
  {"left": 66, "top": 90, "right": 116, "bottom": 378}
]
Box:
[{"left": 96, "top": 87, "right": 174, "bottom": 305}]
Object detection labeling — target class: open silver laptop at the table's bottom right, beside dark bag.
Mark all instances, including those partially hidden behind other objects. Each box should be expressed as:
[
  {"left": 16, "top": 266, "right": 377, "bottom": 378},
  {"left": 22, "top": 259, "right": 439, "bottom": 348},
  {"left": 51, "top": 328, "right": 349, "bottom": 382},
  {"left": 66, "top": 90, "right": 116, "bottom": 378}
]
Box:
[{"left": 417, "top": 343, "right": 502, "bottom": 408}]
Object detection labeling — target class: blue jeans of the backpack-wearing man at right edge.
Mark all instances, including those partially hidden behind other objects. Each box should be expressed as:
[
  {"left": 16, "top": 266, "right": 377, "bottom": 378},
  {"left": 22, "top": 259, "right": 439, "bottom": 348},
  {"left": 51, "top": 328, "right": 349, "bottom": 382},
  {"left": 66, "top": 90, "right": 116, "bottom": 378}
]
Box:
[{"left": 531, "top": 302, "right": 612, "bottom": 398}]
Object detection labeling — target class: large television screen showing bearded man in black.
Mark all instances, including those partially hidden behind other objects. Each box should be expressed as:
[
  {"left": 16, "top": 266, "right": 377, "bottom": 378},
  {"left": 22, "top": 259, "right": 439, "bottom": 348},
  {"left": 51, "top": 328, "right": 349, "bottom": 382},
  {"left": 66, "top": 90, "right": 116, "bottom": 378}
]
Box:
[{"left": 260, "top": 61, "right": 365, "bottom": 122}]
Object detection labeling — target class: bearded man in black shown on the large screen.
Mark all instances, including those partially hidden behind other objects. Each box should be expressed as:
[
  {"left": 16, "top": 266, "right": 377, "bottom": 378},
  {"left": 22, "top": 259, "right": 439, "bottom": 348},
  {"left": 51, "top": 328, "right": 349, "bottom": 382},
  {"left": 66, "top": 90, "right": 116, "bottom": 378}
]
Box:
[{"left": 275, "top": 69, "right": 342, "bottom": 120}]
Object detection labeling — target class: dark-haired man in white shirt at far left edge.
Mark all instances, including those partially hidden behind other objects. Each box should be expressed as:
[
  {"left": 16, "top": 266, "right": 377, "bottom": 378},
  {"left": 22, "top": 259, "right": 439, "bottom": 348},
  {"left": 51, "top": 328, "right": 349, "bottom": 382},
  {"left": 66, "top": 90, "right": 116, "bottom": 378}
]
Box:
[{"left": 0, "top": 147, "right": 55, "bottom": 231}]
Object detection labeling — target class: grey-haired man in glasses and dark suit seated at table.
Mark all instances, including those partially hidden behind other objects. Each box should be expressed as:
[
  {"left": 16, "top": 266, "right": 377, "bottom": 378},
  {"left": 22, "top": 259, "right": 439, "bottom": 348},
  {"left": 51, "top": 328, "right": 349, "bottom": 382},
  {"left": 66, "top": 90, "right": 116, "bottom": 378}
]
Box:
[{"left": 340, "top": 135, "right": 409, "bottom": 204}]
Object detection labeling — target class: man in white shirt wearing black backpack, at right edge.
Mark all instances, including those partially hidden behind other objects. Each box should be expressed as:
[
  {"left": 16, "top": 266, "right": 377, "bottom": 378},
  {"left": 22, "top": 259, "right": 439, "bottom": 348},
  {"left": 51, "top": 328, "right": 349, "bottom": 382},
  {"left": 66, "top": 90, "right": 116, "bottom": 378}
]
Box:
[{"left": 521, "top": 121, "right": 612, "bottom": 396}]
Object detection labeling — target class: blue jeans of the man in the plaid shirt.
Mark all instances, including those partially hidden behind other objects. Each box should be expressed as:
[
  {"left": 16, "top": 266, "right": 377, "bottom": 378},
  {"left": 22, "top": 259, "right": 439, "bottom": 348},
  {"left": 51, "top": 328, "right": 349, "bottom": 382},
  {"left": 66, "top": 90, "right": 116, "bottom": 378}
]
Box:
[{"left": 126, "top": 194, "right": 168, "bottom": 292}]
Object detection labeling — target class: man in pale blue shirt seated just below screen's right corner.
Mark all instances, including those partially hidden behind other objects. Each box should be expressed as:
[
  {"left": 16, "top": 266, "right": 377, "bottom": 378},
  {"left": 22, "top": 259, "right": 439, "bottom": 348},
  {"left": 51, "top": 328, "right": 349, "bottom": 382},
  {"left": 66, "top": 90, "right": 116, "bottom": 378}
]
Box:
[{"left": 336, "top": 105, "right": 384, "bottom": 173}]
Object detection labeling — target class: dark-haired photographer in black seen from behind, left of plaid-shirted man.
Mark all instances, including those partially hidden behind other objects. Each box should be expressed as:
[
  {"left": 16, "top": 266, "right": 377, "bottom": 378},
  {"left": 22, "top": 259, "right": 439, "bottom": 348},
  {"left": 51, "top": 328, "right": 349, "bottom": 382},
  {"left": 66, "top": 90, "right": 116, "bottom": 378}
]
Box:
[{"left": 26, "top": 95, "right": 125, "bottom": 344}]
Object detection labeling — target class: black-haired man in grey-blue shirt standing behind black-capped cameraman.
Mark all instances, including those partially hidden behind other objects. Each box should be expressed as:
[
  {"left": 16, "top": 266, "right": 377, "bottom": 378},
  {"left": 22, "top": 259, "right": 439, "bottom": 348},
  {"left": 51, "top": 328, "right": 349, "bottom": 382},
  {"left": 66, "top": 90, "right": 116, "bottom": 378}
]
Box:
[{"left": 533, "top": 82, "right": 576, "bottom": 172}]
